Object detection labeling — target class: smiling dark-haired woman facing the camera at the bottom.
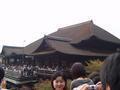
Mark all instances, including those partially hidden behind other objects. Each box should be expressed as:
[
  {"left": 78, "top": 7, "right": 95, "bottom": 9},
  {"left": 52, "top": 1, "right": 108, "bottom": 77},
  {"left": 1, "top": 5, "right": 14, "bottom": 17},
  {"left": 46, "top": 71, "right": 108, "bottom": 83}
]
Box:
[{"left": 51, "top": 71, "right": 67, "bottom": 90}]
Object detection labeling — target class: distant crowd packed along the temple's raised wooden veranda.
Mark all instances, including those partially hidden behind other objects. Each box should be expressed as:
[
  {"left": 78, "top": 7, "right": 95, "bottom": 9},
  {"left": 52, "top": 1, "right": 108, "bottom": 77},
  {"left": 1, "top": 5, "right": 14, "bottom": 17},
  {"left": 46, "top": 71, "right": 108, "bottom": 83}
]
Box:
[{"left": 0, "top": 61, "right": 72, "bottom": 78}]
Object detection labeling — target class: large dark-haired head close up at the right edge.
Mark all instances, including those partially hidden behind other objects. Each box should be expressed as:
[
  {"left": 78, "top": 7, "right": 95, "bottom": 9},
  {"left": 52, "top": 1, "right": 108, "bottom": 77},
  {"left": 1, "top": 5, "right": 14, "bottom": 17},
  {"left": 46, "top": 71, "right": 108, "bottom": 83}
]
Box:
[{"left": 100, "top": 52, "right": 120, "bottom": 90}]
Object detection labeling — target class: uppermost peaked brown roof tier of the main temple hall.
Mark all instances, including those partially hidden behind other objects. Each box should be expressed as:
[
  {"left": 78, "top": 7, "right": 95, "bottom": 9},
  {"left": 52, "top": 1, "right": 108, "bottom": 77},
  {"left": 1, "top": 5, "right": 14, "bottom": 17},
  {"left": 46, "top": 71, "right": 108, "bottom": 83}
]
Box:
[{"left": 50, "top": 21, "right": 120, "bottom": 43}]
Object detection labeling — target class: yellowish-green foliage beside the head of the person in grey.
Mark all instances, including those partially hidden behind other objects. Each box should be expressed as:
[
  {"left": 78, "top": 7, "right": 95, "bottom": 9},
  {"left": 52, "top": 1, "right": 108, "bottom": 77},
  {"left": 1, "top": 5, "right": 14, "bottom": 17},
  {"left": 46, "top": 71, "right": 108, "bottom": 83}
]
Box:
[{"left": 86, "top": 59, "right": 103, "bottom": 73}]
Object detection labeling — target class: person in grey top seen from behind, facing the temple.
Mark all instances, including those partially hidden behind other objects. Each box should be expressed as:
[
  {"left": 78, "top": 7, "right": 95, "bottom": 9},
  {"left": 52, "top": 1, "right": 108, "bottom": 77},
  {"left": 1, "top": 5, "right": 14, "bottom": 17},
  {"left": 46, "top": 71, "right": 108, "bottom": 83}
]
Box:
[{"left": 70, "top": 62, "right": 94, "bottom": 90}]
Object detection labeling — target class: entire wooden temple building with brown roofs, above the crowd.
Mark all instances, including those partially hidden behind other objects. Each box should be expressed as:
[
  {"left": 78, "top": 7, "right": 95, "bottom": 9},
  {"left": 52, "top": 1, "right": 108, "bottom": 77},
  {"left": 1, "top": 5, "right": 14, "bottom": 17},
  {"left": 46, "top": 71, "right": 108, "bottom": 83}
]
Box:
[{"left": 1, "top": 21, "right": 120, "bottom": 65}]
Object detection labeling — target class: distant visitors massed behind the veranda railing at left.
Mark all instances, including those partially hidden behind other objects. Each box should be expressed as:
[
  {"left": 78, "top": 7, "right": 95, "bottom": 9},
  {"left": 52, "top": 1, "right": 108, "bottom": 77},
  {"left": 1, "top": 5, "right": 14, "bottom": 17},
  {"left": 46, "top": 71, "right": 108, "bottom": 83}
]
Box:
[{"left": 2, "top": 64, "right": 57, "bottom": 78}]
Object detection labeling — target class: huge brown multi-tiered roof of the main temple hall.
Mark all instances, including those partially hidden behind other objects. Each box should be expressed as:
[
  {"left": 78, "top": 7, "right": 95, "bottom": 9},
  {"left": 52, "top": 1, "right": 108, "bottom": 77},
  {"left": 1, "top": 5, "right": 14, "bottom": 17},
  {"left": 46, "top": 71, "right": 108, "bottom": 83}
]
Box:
[{"left": 11, "top": 21, "right": 120, "bottom": 56}]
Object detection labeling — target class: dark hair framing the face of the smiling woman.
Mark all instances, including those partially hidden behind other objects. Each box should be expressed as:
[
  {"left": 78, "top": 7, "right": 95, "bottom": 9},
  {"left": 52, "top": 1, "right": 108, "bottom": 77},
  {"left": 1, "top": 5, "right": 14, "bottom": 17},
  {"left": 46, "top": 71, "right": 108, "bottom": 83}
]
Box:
[{"left": 51, "top": 71, "right": 67, "bottom": 90}]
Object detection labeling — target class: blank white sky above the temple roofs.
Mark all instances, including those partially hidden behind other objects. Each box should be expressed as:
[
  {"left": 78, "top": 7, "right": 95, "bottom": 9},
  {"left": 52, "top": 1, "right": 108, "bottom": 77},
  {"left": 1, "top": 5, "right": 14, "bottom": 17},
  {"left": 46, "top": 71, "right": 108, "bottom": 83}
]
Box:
[{"left": 0, "top": 0, "right": 120, "bottom": 49}]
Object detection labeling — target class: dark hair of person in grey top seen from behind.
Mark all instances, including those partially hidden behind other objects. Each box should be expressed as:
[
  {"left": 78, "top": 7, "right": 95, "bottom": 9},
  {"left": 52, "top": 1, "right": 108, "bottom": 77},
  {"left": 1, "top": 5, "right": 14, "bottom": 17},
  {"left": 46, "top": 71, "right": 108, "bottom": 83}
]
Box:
[{"left": 71, "top": 62, "right": 86, "bottom": 79}]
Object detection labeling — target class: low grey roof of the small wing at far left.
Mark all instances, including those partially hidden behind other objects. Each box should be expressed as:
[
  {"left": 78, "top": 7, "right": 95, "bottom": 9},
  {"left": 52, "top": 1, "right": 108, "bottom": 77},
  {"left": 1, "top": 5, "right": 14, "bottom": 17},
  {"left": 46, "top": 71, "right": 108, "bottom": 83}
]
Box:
[{"left": 1, "top": 46, "right": 24, "bottom": 56}]
